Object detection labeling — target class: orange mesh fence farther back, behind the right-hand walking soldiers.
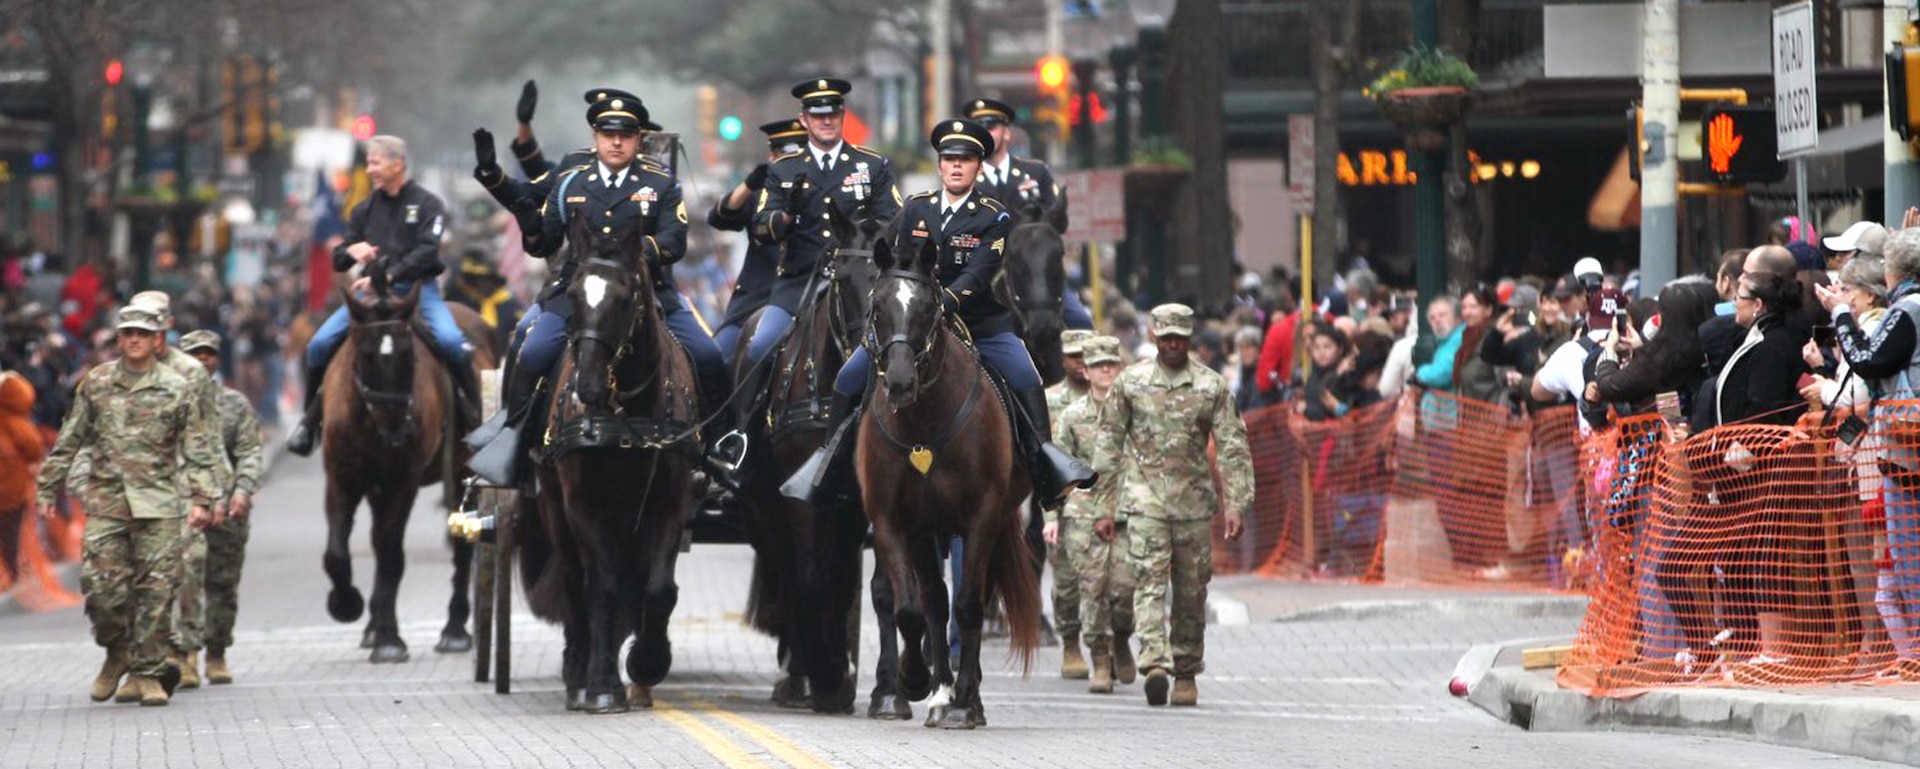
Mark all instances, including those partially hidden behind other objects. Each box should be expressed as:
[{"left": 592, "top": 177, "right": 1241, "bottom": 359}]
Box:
[{"left": 1213, "top": 393, "right": 1586, "bottom": 589}]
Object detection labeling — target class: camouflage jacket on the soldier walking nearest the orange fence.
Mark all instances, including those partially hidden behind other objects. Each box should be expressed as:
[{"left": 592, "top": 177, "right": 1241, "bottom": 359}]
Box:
[{"left": 1094, "top": 359, "right": 1254, "bottom": 520}]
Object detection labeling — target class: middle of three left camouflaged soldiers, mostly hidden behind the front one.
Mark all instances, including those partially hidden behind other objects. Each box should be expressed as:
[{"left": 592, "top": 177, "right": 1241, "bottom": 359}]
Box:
[{"left": 127, "top": 291, "right": 232, "bottom": 688}]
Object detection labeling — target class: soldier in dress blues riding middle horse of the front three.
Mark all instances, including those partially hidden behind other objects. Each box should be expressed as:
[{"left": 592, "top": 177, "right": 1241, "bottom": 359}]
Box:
[{"left": 712, "top": 77, "right": 900, "bottom": 473}]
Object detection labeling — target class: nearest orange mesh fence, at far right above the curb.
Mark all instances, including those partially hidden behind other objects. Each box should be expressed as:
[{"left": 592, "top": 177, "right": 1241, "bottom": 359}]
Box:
[{"left": 1559, "top": 401, "right": 1920, "bottom": 696}]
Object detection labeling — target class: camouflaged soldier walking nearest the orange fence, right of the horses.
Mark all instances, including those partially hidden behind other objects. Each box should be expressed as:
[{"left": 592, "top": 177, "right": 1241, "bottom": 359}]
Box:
[{"left": 1094, "top": 305, "right": 1254, "bottom": 706}]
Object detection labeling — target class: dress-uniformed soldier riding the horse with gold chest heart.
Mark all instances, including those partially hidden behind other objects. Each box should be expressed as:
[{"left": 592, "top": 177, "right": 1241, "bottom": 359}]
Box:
[{"left": 783, "top": 117, "right": 1094, "bottom": 508}]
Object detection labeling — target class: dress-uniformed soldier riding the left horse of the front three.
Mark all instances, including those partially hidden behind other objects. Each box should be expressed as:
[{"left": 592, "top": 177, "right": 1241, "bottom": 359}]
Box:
[{"left": 468, "top": 88, "right": 728, "bottom": 485}]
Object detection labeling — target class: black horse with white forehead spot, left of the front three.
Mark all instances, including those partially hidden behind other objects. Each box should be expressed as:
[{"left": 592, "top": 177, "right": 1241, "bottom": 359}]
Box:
[{"left": 522, "top": 212, "right": 701, "bottom": 713}]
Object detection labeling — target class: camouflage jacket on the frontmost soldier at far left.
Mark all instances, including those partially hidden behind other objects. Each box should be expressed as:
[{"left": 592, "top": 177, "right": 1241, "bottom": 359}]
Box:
[{"left": 38, "top": 361, "right": 221, "bottom": 518}]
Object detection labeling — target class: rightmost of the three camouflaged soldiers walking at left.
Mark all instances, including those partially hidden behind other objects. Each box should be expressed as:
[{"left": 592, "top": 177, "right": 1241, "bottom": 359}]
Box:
[{"left": 180, "top": 330, "right": 265, "bottom": 685}]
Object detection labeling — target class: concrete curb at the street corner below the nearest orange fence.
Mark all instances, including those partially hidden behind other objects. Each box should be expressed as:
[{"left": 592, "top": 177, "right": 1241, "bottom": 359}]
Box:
[{"left": 1457, "top": 639, "right": 1920, "bottom": 765}]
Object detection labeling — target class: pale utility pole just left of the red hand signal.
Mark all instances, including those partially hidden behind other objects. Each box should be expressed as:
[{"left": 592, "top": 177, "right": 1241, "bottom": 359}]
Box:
[{"left": 1640, "top": 0, "right": 1680, "bottom": 297}]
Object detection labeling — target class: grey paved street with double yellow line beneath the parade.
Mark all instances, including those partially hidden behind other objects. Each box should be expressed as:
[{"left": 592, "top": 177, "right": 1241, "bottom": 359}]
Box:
[{"left": 0, "top": 456, "right": 1876, "bottom": 769}]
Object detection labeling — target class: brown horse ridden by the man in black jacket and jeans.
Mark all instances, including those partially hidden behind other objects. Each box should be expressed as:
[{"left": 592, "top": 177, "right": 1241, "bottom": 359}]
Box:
[{"left": 321, "top": 276, "right": 493, "bottom": 662}]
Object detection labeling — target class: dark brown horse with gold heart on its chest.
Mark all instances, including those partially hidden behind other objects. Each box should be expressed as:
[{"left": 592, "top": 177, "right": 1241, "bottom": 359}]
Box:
[{"left": 854, "top": 240, "right": 1041, "bottom": 729}]
